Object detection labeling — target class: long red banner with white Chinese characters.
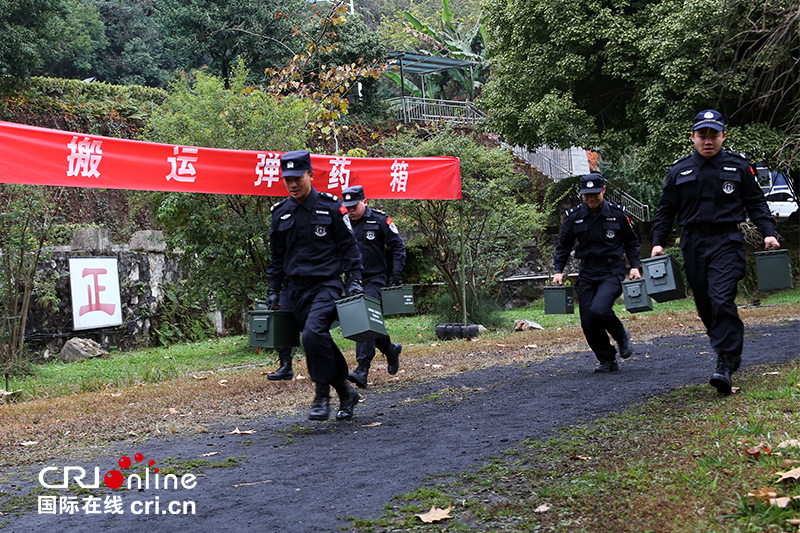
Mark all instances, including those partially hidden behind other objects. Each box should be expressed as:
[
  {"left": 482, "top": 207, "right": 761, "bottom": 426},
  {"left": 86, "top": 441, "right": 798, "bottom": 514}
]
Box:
[{"left": 0, "top": 121, "right": 461, "bottom": 200}]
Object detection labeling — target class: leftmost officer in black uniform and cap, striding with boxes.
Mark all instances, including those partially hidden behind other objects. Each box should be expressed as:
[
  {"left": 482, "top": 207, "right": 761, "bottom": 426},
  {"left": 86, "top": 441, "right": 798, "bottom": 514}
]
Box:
[{"left": 267, "top": 150, "right": 364, "bottom": 420}]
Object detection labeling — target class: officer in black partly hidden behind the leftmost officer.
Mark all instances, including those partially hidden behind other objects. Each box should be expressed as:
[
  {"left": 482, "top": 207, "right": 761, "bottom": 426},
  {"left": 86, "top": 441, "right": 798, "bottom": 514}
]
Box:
[{"left": 342, "top": 185, "right": 406, "bottom": 388}]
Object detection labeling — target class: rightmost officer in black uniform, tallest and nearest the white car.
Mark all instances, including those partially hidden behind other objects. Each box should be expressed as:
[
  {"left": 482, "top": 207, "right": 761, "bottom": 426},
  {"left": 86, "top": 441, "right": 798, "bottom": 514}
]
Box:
[{"left": 651, "top": 109, "right": 780, "bottom": 394}]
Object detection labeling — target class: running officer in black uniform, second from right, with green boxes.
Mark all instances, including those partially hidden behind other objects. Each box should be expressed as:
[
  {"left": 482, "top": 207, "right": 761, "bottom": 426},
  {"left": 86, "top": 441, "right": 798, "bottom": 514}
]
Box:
[{"left": 553, "top": 174, "right": 642, "bottom": 373}]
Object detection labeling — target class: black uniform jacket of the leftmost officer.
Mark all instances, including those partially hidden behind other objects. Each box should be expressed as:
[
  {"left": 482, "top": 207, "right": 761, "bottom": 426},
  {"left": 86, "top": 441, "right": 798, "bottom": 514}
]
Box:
[{"left": 267, "top": 187, "right": 361, "bottom": 291}]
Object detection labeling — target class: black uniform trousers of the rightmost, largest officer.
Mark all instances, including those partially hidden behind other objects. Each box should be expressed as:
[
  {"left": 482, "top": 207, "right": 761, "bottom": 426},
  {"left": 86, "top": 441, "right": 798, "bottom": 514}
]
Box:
[{"left": 680, "top": 228, "right": 746, "bottom": 355}]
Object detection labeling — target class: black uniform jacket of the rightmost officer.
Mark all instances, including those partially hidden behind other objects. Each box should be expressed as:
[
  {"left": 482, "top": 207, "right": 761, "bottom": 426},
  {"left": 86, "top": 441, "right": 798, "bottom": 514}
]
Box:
[{"left": 653, "top": 150, "right": 776, "bottom": 246}]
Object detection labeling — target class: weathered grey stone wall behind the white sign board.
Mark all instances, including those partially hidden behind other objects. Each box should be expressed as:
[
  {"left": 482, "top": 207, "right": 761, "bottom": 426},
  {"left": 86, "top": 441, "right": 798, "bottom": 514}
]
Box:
[{"left": 25, "top": 228, "right": 181, "bottom": 356}]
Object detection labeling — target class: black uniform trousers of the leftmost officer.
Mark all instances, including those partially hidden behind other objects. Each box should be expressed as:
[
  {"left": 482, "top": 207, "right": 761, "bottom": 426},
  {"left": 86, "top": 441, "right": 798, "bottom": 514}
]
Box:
[{"left": 289, "top": 278, "right": 348, "bottom": 385}]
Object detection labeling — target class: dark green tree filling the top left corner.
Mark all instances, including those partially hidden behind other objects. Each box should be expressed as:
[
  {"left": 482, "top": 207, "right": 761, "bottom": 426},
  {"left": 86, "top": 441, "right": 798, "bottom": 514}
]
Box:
[{"left": 0, "top": 0, "right": 61, "bottom": 78}]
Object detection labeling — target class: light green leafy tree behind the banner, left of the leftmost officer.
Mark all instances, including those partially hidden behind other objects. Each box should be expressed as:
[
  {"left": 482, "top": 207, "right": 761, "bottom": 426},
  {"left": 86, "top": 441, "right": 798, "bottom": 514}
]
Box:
[{"left": 145, "top": 60, "right": 316, "bottom": 317}]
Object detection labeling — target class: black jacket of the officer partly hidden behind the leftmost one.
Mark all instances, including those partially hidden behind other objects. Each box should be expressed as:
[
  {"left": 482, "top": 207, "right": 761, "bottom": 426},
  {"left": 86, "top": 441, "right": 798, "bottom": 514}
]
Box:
[{"left": 353, "top": 206, "right": 406, "bottom": 278}]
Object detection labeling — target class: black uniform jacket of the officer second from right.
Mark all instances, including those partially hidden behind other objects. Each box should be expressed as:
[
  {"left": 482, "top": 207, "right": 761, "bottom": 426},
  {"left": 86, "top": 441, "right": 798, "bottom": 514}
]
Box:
[{"left": 553, "top": 200, "right": 641, "bottom": 273}]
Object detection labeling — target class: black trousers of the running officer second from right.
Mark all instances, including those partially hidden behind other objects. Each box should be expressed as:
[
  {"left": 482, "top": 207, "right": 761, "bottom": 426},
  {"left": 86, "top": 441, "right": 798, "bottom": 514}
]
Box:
[{"left": 577, "top": 258, "right": 625, "bottom": 363}]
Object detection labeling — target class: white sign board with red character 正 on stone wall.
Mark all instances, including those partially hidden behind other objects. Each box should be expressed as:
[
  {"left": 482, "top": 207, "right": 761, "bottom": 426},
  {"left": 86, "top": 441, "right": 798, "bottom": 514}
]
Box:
[{"left": 69, "top": 257, "right": 122, "bottom": 329}]
